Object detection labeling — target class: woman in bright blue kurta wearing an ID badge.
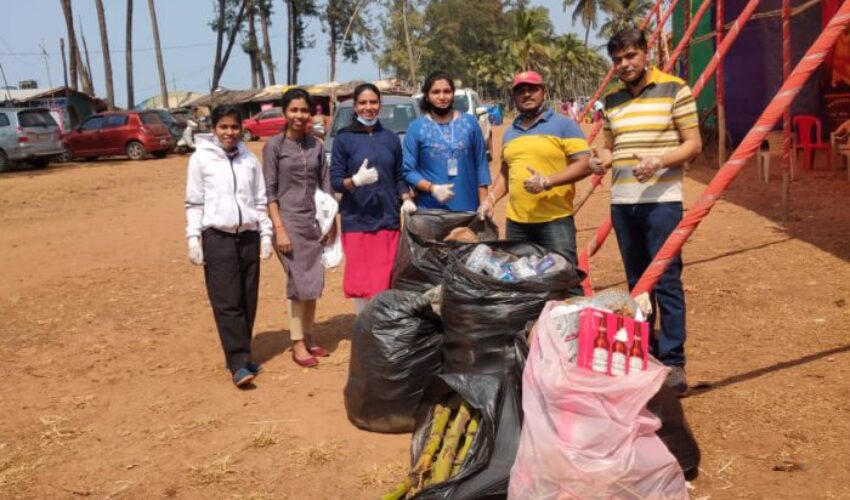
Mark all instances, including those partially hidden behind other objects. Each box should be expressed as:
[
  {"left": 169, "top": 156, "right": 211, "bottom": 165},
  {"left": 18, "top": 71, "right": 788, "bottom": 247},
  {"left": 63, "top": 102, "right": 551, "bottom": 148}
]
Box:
[{"left": 404, "top": 72, "right": 490, "bottom": 212}]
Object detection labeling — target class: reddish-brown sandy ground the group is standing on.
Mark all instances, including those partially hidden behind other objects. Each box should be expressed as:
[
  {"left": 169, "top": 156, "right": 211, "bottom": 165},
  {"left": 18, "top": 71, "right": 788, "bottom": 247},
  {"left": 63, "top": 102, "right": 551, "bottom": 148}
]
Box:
[{"left": 0, "top": 124, "right": 850, "bottom": 500}]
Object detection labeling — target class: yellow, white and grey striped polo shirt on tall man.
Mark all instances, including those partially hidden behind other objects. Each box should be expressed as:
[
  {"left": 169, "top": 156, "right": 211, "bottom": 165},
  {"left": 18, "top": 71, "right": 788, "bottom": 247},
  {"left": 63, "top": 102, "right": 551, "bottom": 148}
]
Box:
[{"left": 604, "top": 67, "right": 699, "bottom": 205}]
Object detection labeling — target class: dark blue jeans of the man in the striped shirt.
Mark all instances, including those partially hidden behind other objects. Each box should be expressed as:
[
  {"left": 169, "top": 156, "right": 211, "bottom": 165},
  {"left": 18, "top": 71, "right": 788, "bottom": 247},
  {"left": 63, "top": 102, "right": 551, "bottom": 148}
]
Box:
[{"left": 611, "top": 203, "right": 685, "bottom": 366}]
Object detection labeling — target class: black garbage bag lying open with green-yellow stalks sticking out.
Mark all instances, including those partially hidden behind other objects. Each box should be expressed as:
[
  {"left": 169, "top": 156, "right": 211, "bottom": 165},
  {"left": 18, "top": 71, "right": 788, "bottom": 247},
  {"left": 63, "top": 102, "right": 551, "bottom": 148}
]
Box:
[{"left": 412, "top": 371, "right": 522, "bottom": 500}]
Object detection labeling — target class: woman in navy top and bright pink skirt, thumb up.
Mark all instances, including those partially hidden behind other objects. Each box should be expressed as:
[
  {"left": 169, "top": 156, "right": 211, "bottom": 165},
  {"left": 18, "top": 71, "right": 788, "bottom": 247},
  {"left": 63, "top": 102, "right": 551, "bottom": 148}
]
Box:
[{"left": 331, "top": 83, "right": 416, "bottom": 313}]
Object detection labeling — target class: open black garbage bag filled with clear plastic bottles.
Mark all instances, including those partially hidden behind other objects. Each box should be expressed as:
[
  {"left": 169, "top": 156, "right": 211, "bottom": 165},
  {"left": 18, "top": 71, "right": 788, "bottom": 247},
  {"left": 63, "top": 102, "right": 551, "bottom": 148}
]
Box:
[{"left": 440, "top": 241, "right": 584, "bottom": 373}]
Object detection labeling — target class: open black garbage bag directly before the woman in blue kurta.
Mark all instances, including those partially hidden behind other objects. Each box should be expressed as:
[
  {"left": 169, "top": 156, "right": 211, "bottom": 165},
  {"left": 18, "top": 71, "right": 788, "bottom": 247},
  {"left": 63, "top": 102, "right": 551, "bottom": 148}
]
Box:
[{"left": 392, "top": 210, "right": 499, "bottom": 292}]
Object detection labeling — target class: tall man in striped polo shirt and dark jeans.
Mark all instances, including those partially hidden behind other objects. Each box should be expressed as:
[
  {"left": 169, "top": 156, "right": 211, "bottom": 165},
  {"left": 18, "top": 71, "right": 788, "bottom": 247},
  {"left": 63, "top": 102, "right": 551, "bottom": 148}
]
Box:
[{"left": 591, "top": 28, "right": 702, "bottom": 394}]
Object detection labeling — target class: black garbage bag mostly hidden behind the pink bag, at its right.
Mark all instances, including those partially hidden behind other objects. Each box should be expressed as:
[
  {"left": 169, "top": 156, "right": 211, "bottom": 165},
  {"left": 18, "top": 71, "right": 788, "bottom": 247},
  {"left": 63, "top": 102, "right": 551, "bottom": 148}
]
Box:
[{"left": 646, "top": 384, "right": 701, "bottom": 481}]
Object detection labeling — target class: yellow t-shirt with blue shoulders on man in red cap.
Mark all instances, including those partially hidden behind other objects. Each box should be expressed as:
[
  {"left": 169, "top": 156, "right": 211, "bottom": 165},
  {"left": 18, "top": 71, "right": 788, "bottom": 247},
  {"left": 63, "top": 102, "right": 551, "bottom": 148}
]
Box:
[{"left": 502, "top": 109, "right": 590, "bottom": 223}]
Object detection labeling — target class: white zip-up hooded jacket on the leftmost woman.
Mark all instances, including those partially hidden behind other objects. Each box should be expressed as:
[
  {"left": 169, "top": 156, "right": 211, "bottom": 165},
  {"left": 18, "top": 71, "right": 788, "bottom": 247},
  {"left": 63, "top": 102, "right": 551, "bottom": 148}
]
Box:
[{"left": 186, "top": 134, "right": 272, "bottom": 238}]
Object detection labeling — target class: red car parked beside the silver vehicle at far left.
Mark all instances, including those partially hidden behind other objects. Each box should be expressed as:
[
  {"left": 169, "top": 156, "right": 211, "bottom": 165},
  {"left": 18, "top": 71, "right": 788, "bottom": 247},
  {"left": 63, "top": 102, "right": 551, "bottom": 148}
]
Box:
[{"left": 63, "top": 111, "right": 174, "bottom": 160}]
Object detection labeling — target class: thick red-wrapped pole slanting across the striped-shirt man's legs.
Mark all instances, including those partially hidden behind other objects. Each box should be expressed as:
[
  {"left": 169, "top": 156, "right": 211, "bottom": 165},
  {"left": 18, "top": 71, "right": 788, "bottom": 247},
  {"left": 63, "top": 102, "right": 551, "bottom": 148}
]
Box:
[{"left": 632, "top": 1, "right": 850, "bottom": 296}]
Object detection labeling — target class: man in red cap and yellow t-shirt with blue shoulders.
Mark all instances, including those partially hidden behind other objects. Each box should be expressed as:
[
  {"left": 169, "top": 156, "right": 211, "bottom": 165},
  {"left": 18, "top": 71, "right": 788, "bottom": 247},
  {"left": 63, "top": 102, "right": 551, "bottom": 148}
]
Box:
[{"left": 478, "top": 71, "right": 591, "bottom": 295}]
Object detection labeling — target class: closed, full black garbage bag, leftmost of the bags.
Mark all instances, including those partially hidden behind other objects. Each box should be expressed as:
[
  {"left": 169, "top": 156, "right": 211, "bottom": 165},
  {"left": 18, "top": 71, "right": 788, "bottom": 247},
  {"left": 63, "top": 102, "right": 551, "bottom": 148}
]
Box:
[{"left": 344, "top": 290, "right": 443, "bottom": 432}]
